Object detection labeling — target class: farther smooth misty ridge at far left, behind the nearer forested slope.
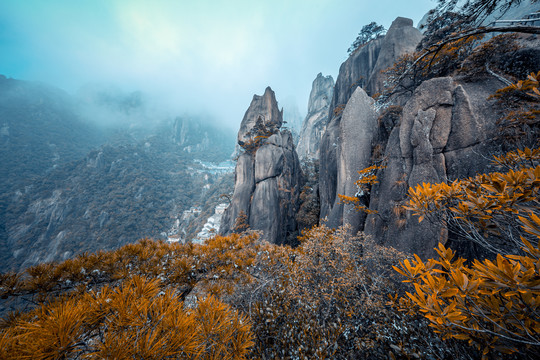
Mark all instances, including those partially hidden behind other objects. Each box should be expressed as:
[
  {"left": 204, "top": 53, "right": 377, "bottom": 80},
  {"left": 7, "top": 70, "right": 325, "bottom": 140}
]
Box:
[{"left": 0, "top": 75, "right": 105, "bottom": 193}]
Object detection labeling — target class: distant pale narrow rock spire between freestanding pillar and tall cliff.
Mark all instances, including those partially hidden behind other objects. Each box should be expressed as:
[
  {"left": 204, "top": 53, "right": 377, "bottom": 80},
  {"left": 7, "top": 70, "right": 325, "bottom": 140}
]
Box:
[{"left": 297, "top": 73, "right": 334, "bottom": 159}]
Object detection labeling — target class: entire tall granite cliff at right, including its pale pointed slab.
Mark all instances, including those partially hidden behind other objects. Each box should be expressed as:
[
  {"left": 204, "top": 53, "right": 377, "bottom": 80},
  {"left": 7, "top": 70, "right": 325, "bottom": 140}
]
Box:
[{"left": 319, "top": 18, "right": 538, "bottom": 258}]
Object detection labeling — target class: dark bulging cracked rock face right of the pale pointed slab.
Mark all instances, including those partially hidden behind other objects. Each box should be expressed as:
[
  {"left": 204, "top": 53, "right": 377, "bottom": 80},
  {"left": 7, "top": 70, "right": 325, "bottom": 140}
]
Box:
[{"left": 365, "top": 77, "right": 499, "bottom": 257}]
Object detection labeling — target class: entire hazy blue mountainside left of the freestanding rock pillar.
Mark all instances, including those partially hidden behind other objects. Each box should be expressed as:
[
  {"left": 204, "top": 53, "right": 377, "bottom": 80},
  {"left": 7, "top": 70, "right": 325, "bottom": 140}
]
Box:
[{"left": 0, "top": 77, "right": 234, "bottom": 271}]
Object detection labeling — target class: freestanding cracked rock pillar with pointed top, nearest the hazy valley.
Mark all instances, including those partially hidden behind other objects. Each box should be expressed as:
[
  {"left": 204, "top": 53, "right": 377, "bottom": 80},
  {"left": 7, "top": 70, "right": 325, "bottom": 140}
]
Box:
[{"left": 220, "top": 88, "right": 302, "bottom": 244}]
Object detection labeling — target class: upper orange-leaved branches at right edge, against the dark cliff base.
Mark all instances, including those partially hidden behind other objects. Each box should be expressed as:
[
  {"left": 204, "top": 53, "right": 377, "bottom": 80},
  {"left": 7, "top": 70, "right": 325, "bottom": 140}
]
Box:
[{"left": 406, "top": 149, "right": 540, "bottom": 254}]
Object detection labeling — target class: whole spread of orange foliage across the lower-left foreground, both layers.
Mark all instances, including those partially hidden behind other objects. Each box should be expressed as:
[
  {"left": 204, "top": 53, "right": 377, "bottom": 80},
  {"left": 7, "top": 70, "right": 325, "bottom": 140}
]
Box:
[{"left": 0, "top": 234, "right": 261, "bottom": 359}]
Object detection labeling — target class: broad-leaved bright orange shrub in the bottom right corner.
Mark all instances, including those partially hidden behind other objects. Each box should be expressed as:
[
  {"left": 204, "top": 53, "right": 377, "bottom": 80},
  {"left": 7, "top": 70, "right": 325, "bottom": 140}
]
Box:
[{"left": 394, "top": 236, "right": 540, "bottom": 356}]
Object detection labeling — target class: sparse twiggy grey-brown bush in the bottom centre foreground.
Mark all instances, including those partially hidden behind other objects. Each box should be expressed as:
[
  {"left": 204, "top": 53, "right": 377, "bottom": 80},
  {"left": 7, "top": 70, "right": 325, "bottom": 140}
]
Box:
[{"left": 234, "top": 226, "right": 467, "bottom": 359}]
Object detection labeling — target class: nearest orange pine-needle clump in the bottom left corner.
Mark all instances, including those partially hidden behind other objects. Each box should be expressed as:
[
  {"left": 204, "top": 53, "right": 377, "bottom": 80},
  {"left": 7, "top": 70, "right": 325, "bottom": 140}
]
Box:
[{"left": 0, "top": 276, "right": 253, "bottom": 360}]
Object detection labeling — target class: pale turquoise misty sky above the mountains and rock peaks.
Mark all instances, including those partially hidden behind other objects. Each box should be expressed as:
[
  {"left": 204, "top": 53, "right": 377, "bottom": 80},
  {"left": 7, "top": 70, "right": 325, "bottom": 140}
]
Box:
[{"left": 0, "top": 0, "right": 436, "bottom": 127}]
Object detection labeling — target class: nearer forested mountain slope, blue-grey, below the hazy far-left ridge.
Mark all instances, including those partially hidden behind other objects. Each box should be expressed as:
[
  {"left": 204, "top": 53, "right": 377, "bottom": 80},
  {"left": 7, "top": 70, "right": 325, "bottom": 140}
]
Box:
[{"left": 0, "top": 130, "right": 234, "bottom": 270}]
